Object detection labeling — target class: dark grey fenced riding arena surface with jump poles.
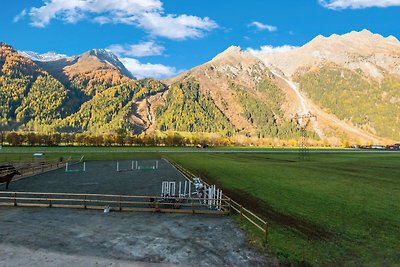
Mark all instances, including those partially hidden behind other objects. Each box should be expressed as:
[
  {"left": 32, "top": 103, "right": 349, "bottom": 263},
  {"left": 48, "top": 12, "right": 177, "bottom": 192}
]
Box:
[{"left": 0, "top": 160, "right": 186, "bottom": 196}]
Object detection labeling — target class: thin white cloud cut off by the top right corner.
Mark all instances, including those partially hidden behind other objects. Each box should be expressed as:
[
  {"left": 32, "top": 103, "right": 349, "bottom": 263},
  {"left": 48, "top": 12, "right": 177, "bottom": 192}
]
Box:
[{"left": 318, "top": 0, "right": 400, "bottom": 10}]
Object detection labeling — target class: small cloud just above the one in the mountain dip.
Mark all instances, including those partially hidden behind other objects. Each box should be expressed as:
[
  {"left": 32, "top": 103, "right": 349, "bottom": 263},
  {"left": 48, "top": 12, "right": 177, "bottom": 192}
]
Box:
[{"left": 108, "top": 41, "right": 165, "bottom": 57}]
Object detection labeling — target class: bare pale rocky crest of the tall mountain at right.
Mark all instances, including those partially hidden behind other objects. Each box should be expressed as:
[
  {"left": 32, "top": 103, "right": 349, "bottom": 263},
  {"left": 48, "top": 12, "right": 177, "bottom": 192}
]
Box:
[{"left": 255, "top": 30, "right": 400, "bottom": 79}]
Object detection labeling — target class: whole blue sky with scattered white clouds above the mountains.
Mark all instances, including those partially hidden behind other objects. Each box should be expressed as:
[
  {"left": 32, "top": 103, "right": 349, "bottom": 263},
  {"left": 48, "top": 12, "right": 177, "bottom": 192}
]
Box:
[{"left": 0, "top": 0, "right": 400, "bottom": 78}]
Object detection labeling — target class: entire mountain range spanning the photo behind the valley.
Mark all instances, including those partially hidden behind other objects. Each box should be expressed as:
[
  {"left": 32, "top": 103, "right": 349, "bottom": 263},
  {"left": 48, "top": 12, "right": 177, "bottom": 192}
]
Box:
[{"left": 0, "top": 30, "right": 400, "bottom": 144}]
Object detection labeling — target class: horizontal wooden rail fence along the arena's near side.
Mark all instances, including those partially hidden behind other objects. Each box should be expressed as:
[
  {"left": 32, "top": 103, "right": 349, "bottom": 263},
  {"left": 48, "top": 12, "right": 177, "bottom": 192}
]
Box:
[{"left": 0, "top": 192, "right": 230, "bottom": 217}]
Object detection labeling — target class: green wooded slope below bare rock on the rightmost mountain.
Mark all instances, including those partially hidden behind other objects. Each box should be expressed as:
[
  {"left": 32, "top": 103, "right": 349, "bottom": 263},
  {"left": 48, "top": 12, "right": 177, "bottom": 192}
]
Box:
[{"left": 297, "top": 65, "right": 400, "bottom": 140}]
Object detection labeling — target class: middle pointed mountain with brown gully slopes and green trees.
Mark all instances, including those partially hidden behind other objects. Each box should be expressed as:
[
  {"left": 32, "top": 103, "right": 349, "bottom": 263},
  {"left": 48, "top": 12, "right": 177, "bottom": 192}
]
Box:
[{"left": 157, "top": 46, "right": 299, "bottom": 139}]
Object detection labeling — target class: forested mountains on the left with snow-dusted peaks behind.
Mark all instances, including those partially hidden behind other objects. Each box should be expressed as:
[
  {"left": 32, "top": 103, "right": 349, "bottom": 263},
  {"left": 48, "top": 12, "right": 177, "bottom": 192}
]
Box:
[{"left": 0, "top": 43, "right": 165, "bottom": 133}]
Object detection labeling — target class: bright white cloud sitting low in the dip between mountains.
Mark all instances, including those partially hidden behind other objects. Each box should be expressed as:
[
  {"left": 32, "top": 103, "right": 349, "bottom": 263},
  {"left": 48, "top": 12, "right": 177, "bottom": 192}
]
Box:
[{"left": 119, "top": 58, "right": 183, "bottom": 79}]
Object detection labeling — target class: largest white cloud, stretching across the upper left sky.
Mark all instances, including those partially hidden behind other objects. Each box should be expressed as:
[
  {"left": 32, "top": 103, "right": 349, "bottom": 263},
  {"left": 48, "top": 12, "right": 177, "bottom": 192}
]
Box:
[{"left": 24, "top": 0, "right": 218, "bottom": 40}]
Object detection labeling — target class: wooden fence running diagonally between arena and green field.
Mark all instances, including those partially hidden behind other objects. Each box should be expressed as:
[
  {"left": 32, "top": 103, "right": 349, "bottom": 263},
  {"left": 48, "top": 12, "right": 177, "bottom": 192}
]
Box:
[{"left": 164, "top": 159, "right": 269, "bottom": 242}]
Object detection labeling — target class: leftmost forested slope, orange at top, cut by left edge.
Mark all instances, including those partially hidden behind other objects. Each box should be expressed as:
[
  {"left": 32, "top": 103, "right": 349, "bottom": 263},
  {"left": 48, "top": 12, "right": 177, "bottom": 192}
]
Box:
[{"left": 0, "top": 43, "right": 69, "bottom": 129}]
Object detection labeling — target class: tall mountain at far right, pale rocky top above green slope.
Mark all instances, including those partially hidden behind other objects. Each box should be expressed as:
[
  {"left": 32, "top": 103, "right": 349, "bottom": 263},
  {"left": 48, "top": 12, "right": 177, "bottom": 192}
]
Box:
[{"left": 255, "top": 30, "right": 400, "bottom": 142}]
